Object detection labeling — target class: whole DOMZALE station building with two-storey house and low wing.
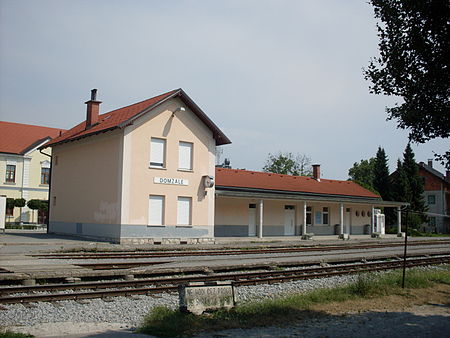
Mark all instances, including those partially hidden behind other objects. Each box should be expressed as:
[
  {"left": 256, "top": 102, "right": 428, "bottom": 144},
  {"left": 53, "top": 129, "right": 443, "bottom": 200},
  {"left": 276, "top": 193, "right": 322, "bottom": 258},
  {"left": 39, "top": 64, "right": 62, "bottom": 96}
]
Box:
[{"left": 42, "top": 89, "right": 405, "bottom": 243}]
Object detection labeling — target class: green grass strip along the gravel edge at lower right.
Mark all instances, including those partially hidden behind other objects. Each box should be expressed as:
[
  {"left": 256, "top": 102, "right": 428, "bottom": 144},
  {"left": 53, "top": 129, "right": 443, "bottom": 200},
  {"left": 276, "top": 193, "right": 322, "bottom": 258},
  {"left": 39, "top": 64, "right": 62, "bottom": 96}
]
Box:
[{"left": 138, "top": 267, "right": 450, "bottom": 337}]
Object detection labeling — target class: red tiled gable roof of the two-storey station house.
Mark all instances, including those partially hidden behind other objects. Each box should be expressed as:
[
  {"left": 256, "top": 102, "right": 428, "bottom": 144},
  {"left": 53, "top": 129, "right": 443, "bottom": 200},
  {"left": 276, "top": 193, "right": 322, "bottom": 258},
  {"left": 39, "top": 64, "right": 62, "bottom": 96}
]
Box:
[{"left": 45, "top": 89, "right": 231, "bottom": 147}]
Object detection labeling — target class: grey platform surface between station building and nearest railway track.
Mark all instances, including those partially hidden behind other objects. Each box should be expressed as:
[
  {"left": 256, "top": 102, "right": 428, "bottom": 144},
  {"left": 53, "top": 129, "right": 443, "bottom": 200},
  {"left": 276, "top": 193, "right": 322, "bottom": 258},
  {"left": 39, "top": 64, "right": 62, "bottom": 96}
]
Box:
[{"left": 0, "top": 230, "right": 450, "bottom": 283}]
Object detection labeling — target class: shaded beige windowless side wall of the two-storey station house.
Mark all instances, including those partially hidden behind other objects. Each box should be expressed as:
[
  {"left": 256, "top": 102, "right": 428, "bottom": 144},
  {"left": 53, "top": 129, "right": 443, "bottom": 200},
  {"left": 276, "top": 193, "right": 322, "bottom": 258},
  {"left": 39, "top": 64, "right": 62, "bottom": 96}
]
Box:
[{"left": 50, "top": 130, "right": 123, "bottom": 224}]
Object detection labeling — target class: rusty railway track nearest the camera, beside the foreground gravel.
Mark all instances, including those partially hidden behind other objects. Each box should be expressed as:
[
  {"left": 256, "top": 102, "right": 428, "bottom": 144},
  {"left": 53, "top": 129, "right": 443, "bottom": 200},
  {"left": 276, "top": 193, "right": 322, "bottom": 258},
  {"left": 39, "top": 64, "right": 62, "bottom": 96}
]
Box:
[{"left": 0, "top": 255, "right": 450, "bottom": 304}]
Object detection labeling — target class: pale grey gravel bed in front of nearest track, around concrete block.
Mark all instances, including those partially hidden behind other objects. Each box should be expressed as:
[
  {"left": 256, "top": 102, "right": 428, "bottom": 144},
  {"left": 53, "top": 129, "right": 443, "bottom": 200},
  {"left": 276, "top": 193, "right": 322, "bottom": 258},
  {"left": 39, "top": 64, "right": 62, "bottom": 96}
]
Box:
[{"left": 0, "top": 276, "right": 356, "bottom": 327}]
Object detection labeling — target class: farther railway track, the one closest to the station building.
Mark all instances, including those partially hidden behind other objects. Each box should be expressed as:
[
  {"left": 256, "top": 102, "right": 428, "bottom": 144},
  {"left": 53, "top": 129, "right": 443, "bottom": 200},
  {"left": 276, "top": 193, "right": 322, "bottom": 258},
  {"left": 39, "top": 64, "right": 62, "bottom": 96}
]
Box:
[{"left": 30, "top": 241, "right": 450, "bottom": 259}]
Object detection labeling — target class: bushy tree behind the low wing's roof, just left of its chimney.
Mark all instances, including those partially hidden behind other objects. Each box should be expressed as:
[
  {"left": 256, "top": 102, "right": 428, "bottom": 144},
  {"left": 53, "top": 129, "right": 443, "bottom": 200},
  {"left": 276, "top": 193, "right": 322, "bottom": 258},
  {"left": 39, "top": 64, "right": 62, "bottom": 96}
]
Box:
[{"left": 263, "top": 152, "right": 312, "bottom": 176}]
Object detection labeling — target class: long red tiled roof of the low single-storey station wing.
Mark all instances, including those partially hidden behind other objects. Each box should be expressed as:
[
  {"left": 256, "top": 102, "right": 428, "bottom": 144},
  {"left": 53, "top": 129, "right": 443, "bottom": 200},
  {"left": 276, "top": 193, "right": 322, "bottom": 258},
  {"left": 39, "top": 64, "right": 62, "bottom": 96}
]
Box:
[{"left": 215, "top": 168, "right": 380, "bottom": 199}]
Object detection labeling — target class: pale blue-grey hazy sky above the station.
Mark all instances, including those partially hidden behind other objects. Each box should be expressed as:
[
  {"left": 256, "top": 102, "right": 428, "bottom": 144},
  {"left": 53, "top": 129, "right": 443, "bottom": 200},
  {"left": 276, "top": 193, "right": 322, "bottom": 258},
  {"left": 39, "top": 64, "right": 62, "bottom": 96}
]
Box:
[{"left": 0, "top": 0, "right": 450, "bottom": 179}]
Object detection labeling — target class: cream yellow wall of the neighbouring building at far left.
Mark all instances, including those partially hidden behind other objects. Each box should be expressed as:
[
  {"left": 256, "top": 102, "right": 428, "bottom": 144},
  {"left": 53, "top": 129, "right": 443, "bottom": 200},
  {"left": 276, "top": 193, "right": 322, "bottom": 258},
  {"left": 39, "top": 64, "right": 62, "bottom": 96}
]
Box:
[{"left": 0, "top": 149, "right": 51, "bottom": 222}]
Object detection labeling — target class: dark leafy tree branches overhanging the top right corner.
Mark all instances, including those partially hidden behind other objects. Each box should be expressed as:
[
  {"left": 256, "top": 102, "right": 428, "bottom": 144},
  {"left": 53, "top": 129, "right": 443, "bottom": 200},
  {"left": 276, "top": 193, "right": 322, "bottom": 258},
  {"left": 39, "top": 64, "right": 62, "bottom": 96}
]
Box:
[{"left": 364, "top": 0, "right": 450, "bottom": 169}]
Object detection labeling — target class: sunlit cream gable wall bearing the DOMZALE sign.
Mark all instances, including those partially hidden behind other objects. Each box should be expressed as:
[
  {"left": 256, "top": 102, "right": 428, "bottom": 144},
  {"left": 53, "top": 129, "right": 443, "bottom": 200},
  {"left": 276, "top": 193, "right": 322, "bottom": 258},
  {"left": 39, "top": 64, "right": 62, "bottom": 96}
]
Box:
[{"left": 121, "top": 99, "right": 215, "bottom": 226}]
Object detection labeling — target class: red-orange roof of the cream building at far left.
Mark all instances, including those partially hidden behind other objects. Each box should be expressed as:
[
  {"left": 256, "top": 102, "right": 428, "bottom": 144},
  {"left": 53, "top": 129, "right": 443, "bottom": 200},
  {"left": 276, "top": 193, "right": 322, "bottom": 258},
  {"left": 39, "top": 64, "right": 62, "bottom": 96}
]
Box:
[{"left": 0, "top": 121, "right": 65, "bottom": 155}]
